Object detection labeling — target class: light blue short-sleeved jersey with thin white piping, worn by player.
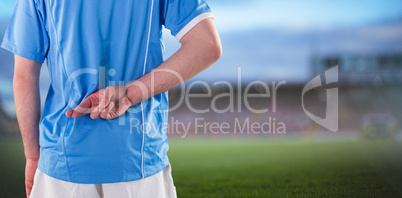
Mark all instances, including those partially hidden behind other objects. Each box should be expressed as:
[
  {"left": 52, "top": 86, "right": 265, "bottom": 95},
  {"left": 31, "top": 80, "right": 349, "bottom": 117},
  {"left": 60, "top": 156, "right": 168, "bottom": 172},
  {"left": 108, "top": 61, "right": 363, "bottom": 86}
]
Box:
[{"left": 1, "top": 0, "right": 212, "bottom": 184}]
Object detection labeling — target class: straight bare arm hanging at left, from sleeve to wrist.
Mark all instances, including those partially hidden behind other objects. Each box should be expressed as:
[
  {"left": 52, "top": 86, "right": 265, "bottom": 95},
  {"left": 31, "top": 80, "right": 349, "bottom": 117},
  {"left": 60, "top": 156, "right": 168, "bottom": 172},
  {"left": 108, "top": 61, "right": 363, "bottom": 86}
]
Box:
[{"left": 13, "top": 55, "right": 40, "bottom": 160}]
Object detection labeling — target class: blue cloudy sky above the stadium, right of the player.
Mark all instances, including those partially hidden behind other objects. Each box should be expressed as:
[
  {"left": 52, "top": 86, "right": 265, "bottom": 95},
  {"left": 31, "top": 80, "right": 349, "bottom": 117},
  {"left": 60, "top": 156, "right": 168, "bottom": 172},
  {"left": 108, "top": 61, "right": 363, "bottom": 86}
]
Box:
[{"left": 160, "top": 0, "right": 402, "bottom": 82}]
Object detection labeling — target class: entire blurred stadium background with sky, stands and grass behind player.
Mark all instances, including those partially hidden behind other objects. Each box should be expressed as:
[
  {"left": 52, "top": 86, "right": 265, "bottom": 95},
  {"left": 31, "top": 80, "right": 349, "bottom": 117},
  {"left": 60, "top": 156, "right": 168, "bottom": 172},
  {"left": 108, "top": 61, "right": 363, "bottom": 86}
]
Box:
[{"left": 0, "top": 0, "right": 402, "bottom": 197}]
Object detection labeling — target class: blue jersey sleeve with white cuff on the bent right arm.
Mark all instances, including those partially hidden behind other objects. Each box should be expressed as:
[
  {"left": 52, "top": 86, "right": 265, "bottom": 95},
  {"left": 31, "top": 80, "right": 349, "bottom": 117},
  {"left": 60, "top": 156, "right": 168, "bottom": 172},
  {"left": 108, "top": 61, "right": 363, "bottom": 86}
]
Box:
[{"left": 163, "top": 0, "right": 213, "bottom": 41}]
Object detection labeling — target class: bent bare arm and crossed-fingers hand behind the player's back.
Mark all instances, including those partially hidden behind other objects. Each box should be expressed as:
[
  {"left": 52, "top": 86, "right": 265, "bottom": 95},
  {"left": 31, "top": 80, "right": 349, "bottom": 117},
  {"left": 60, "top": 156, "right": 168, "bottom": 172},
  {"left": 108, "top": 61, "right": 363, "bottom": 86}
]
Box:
[{"left": 66, "top": 18, "right": 222, "bottom": 119}]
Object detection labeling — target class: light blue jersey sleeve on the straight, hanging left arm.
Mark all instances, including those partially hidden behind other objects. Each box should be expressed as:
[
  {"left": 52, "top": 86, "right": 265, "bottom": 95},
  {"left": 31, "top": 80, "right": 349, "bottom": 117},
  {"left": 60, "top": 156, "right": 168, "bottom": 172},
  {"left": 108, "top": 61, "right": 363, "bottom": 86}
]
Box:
[{"left": 1, "top": 0, "right": 49, "bottom": 63}]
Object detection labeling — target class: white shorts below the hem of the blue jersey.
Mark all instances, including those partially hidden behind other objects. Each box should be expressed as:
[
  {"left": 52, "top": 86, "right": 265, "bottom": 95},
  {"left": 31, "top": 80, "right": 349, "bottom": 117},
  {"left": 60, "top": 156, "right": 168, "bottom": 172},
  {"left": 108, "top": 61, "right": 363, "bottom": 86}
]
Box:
[{"left": 30, "top": 164, "right": 177, "bottom": 198}]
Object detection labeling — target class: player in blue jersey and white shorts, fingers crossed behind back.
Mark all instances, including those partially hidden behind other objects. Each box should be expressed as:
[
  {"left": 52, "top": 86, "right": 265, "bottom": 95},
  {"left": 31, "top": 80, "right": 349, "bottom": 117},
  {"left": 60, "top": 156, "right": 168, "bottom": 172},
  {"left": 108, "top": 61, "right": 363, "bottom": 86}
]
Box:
[{"left": 1, "top": 0, "right": 222, "bottom": 198}]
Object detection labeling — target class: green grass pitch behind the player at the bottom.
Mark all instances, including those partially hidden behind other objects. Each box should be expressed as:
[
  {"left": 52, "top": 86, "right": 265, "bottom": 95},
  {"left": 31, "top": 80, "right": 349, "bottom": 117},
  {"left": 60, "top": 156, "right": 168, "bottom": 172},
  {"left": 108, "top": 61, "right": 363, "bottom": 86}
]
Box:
[{"left": 0, "top": 139, "right": 402, "bottom": 197}]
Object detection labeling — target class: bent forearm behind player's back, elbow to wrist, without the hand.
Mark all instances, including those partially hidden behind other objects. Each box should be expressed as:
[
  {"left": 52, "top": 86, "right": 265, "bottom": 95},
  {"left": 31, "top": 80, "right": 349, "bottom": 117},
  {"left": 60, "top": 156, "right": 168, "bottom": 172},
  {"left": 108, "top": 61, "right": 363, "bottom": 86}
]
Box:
[{"left": 126, "top": 19, "right": 222, "bottom": 104}]
